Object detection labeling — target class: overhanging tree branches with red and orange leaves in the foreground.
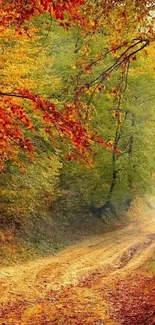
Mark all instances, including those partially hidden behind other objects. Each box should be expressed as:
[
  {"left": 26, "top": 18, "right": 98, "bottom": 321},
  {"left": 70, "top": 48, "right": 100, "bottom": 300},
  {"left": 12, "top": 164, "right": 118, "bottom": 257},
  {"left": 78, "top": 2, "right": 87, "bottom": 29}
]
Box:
[{"left": 0, "top": 0, "right": 154, "bottom": 170}]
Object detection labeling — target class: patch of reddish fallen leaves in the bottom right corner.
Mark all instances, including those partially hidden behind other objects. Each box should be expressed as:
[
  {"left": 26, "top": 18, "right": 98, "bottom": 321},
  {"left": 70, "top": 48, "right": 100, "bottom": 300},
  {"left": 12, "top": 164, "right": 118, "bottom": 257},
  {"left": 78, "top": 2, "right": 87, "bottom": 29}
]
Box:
[{"left": 107, "top": 274, "right": 155, "bottom": 325}]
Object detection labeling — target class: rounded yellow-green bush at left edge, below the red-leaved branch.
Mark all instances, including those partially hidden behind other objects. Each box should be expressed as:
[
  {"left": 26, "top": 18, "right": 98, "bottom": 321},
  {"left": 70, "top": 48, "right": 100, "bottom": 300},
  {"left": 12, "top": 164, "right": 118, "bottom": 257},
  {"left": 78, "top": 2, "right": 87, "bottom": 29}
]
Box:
[{"left": 0, "top": 153, "right": 61, "bottom": 230}]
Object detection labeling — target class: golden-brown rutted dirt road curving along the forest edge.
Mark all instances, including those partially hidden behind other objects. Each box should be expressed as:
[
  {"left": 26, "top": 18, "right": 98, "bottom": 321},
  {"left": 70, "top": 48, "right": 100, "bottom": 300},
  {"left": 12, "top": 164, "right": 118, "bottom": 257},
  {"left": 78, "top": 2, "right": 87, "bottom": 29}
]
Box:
[{"left": 0, "top": 206, "right": 155, "bottom": 325}]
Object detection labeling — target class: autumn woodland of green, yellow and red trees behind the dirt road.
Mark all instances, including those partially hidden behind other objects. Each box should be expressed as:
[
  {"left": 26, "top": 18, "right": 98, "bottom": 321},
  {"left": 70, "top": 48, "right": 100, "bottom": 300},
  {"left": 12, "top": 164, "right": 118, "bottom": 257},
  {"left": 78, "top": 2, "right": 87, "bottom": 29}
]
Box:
[{"left": 0, "top": 1, "right": 155, "bottom": 265}]
